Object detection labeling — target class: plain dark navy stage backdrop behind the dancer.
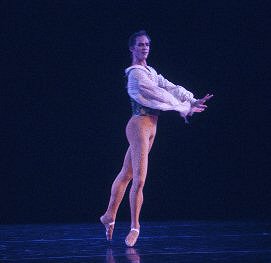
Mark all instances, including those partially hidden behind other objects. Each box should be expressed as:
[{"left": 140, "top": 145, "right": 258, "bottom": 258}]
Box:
[{"left": 0, "top": 0, "right": 271, "bottom": 223}]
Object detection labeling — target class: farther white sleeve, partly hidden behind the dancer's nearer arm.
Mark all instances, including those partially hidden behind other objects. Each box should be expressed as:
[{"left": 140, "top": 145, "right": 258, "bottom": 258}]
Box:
[{"left": 157, "top": 74, "right": 196, "bottom": 103}]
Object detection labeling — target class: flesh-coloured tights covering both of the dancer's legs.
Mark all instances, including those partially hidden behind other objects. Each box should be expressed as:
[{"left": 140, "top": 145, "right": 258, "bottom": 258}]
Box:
[{"left": 104, "top": 115, "right": 158, "bottom": 229}]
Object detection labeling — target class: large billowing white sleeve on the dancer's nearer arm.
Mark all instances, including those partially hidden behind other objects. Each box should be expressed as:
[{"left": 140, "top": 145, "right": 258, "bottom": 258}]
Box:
[{"left": 127, "top": 68, "right": 191, "bottom": 116}]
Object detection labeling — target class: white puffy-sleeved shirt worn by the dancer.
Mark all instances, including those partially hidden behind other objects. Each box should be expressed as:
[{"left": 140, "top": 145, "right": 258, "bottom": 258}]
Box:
[{"left": 125, "top": 65, "right": 196, "bottom": 118}]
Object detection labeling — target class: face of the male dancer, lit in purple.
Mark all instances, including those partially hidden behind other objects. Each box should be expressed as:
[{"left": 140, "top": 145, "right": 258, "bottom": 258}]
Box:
[{"left": 130, "top": 36, "right": 150, "bottom": 61}]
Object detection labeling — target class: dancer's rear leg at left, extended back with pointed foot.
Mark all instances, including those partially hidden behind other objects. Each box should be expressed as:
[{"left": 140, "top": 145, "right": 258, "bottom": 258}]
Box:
[{"left": 100, "top": 147, "right": 132, "bottom": 240}]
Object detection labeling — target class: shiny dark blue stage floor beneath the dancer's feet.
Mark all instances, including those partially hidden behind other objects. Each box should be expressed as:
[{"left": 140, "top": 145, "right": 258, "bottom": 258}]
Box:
[{"left": 0, "top": 221, "right": 271, "bottom": 263}]
